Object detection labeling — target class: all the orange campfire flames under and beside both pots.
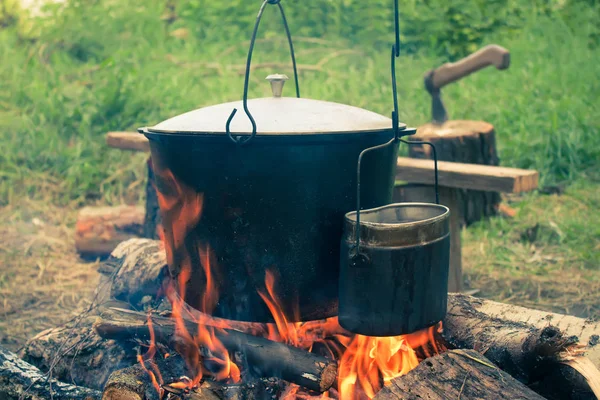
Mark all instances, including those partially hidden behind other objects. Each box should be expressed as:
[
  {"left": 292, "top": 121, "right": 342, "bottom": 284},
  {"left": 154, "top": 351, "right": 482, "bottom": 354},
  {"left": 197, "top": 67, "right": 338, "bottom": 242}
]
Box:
[{"left": 139, "top": 165, "right": 443, "bottom": 400}]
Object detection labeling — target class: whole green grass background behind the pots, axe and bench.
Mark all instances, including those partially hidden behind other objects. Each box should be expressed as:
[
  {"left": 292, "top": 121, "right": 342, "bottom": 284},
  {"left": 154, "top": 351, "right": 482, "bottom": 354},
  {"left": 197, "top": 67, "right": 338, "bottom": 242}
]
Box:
[{"left": 0, "top": 0, "right": 600, "bottom": 328}]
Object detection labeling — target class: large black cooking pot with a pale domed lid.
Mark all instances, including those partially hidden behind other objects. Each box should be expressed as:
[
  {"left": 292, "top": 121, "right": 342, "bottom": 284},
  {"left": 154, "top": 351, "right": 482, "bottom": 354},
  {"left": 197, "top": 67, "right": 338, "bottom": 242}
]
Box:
[{"left": 140, "top": 76, "right": 405, "bottom": 322}]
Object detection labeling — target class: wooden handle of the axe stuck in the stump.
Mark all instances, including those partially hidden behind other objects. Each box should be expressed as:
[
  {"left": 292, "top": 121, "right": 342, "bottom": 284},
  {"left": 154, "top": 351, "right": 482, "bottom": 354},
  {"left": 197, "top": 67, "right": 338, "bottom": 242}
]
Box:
[{"left": 432, "top": 44, "right": 510, "bottom": 89}]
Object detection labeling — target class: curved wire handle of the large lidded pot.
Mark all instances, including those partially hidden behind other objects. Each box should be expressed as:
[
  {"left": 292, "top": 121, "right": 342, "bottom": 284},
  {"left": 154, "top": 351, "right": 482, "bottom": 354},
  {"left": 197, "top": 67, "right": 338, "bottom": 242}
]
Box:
[{"left": 225, "top": 0, "right": 300, "bottom": 145}]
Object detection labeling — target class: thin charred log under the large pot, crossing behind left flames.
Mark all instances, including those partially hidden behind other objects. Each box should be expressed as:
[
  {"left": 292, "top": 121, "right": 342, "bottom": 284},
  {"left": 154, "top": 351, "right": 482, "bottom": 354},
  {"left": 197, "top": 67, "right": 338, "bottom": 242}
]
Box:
[{"left": 94, "top": 309, "right": 337, "bottom": 393}]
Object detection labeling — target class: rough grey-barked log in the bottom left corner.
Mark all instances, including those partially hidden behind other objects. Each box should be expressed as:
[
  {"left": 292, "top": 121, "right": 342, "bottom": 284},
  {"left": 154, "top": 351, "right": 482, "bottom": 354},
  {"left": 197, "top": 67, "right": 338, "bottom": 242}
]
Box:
[{"left": 0, "top": 346, "right": 100, "bottom": 400}]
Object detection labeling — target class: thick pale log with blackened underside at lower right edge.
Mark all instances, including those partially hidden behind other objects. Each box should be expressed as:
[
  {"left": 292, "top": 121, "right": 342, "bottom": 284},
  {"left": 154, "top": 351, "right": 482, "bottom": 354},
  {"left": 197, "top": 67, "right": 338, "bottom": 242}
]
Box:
[{"left": 443, "top": 294, "right": 600, "bottom": 399}]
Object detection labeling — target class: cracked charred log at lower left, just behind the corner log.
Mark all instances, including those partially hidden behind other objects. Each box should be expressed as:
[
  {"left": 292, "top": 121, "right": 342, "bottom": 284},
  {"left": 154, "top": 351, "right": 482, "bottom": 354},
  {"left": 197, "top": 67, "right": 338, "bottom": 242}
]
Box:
[{"left": 19, "top": 318, "right": 136, "bottom": 390}]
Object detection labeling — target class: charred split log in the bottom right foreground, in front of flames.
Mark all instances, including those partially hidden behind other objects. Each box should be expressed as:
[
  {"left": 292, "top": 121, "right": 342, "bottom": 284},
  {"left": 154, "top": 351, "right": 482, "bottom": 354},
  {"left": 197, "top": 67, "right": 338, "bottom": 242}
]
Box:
[{"left": 374, "top": 350, "right": 544, "bottom": 400}]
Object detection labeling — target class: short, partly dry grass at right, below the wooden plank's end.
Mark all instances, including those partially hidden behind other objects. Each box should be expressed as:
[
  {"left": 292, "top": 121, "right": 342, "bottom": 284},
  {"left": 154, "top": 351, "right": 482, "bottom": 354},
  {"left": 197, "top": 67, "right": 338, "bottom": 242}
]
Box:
[{"left": 463, "top": 180, "right": 600, "bottom": 317}]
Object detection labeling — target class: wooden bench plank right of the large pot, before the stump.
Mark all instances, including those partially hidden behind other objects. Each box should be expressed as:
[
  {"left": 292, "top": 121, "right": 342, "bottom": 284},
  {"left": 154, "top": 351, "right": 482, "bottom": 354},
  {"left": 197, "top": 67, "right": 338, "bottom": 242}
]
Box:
[{"left": 396, "top": 157, "right": 539, "bottom": 193}]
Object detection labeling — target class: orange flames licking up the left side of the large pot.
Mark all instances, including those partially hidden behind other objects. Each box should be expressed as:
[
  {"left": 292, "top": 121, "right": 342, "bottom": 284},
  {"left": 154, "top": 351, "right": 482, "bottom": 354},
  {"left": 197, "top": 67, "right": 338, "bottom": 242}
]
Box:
[{"left": 140, "top": 165, "right": 240, "bottom": 394}]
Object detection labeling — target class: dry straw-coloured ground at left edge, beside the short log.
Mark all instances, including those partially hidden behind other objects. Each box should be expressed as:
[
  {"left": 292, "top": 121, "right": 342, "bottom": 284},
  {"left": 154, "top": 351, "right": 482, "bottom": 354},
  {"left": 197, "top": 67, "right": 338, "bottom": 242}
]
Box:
[{"left": 0, "top": 201, "right": 99, "bottom": 351}]
